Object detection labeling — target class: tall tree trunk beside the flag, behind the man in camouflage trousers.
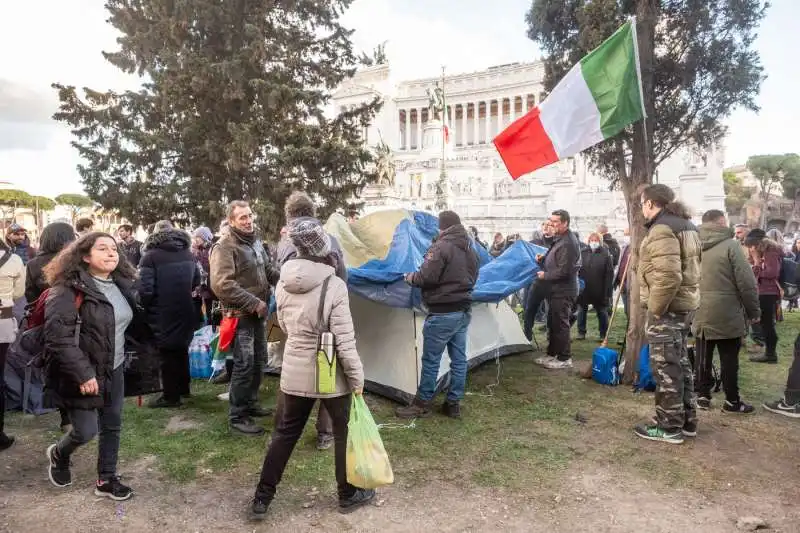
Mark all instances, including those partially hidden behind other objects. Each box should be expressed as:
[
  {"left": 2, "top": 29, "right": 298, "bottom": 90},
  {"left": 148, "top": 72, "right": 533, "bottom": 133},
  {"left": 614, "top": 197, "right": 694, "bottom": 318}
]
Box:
[{"left": 622, "top": 0, "right": 657, "bottom": 384}]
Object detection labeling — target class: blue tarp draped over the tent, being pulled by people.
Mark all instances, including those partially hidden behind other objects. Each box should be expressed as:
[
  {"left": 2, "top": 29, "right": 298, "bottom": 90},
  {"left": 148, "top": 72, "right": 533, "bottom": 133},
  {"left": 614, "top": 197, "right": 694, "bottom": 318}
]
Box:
[{"left": 348, "top": 211, "right": 560, "bottom": 308}]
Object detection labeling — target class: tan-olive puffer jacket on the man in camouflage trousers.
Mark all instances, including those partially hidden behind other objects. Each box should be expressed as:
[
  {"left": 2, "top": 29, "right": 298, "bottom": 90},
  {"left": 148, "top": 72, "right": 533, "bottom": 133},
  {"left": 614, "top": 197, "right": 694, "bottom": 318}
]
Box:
[{"left": 637, "top": 210, "right": 702, "bottom": 317}]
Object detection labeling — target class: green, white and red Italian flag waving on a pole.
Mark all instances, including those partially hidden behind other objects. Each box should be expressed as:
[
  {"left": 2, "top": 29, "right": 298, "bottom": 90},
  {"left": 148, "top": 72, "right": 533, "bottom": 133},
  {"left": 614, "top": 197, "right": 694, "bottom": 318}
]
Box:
[{"left": 494, "top": 20, "right": 645, "bottom": 179}]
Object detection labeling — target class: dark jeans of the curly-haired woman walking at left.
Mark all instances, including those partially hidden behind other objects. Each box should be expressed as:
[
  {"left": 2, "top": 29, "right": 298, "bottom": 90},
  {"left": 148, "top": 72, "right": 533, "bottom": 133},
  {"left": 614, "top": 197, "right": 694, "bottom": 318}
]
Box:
[{"left": 56, "top": 365, "right": 125, "bottom": 481}]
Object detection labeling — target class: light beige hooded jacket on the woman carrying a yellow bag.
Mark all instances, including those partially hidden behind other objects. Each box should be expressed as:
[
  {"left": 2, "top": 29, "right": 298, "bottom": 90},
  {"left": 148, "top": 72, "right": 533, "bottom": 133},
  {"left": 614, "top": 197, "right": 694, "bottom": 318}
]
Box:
[{"left": 275, "top": 259, "right": 364, "bottom": 398}]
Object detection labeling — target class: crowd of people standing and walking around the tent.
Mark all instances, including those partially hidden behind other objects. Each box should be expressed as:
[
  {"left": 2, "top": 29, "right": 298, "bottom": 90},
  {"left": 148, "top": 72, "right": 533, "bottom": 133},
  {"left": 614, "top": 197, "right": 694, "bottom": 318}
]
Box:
[{"left": 0, "top": 185, "right": 800, "bottom": 520}]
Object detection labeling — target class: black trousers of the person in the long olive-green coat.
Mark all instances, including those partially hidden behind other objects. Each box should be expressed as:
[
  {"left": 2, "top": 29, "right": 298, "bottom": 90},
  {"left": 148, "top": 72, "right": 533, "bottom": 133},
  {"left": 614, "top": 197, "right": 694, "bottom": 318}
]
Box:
[{"left": 695, "top": 338, "right": 742, "bottom": 403}]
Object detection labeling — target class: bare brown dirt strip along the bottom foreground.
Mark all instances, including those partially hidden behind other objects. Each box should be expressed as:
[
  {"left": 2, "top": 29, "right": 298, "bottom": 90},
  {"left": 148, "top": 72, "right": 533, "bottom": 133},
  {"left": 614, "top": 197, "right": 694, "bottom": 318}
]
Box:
[{"left": 0, "top": 446, "right": 800, "bottom": 533}]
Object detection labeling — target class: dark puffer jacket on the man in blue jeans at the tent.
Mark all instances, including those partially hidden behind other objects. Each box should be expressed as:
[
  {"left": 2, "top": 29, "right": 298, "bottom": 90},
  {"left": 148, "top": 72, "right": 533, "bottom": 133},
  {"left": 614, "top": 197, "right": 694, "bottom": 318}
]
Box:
[{"left": 411, "top": 224, "right": 478, "bottom": 314}]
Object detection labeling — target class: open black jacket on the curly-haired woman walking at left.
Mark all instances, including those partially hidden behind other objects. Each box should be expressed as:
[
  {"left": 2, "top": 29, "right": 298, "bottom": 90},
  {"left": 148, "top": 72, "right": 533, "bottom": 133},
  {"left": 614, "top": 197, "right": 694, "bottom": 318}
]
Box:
[{"left": 44, "top": 271, "right": 152, "bottom": 409}]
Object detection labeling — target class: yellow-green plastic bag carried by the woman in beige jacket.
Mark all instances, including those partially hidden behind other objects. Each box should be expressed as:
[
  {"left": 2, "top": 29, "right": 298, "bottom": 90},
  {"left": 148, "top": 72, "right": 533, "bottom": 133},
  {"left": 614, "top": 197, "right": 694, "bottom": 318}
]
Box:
[{"left": 347, "top": 394, "right": 394, "bottom": 489}]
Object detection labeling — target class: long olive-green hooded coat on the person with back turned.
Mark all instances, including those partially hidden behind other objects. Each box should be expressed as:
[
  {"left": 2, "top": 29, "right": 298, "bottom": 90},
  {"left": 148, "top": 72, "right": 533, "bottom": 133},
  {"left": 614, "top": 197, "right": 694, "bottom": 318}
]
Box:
[{"left": 692, "top": 223, "right": 761, "bottom": 340}]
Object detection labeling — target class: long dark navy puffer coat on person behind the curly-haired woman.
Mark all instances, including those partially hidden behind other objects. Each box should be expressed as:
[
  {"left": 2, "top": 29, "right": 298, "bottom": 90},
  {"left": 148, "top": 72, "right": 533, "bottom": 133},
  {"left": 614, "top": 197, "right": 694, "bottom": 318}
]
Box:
[{"left": 139, "top": 230, "right": 200, "bottom": 350}]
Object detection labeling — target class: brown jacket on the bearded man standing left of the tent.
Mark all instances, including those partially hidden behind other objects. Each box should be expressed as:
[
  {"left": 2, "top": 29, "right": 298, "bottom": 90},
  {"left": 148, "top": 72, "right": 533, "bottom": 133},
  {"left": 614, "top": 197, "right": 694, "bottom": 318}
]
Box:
[{"left": 209, "top": 228, "right": 280, "bottom": 317}]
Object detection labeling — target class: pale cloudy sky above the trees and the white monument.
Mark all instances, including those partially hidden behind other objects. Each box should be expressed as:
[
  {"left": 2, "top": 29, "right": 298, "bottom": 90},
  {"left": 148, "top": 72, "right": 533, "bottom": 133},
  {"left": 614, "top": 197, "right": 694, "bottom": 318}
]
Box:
[{"left": 0, "top": 0, "right": 800, "bottom": 197}]
